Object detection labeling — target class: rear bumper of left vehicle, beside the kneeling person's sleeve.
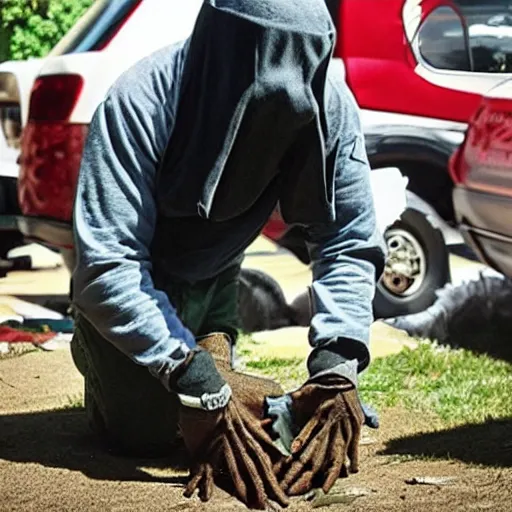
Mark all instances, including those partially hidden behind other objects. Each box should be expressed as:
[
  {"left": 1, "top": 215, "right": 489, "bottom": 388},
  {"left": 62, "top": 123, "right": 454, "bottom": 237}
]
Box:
[{"left": 17, "top": 216, "right": 74, "bottom": 249}]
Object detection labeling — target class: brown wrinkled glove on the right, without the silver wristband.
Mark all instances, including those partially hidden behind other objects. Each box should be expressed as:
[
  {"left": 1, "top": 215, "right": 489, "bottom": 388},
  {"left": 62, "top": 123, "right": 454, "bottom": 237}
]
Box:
[{"left": 275, "top": 377, "right": 364, "bottom": 496}]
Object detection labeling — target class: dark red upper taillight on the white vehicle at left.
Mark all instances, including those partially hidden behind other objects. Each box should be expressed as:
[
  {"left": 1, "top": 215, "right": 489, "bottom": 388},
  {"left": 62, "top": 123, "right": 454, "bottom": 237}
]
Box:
[{"left": 28, "top": 74, "right": 84, "bottom": 122}]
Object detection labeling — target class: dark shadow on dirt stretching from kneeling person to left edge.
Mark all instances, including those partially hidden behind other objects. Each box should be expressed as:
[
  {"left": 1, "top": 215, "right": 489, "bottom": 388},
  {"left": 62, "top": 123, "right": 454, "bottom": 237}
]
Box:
[{"left": 0, "top": 409, "right": 186, "bottom": 486}]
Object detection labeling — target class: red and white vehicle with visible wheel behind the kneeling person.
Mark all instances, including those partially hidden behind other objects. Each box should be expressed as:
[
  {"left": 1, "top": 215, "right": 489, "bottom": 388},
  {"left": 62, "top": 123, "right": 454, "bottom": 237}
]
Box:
[{"left": 264, "top": 0, "right": 512, "bottom": 317}]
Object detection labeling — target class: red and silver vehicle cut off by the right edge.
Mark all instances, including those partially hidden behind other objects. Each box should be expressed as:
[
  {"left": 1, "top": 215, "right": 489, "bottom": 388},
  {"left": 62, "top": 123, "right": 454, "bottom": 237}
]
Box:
[{"left": 450, "top": 80, "right": 512, "bottom": 277}]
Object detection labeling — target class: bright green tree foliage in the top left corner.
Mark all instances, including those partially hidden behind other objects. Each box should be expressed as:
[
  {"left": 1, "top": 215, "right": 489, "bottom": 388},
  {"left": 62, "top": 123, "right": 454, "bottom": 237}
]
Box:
[{"left": 0, "top": 0, "right": 93, "bottom": 60}]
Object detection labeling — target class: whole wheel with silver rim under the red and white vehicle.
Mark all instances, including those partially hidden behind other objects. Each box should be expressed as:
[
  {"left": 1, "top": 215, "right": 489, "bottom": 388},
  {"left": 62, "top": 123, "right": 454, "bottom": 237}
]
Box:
[{"left": 373, "top": 209, "right": 450, "bottom": 318}]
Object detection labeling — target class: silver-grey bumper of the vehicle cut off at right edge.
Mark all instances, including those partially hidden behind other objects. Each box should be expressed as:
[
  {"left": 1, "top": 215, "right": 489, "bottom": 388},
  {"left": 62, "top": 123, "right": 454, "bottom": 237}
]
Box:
[{"left": 453, "top": 187, "right": 512, "bottom": 277}]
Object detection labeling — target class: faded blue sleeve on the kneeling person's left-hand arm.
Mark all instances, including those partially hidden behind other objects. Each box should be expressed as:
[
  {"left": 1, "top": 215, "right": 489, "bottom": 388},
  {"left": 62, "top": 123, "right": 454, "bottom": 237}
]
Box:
[{"left": 73, "top": 65, "right": 195, "bottom": 382}]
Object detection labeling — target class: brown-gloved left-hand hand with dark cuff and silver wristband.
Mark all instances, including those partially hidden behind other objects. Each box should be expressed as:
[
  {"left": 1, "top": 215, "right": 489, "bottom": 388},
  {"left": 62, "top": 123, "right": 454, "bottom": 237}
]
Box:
[{"left": 170, "top": 350, "right": 288, "bottom": 509}]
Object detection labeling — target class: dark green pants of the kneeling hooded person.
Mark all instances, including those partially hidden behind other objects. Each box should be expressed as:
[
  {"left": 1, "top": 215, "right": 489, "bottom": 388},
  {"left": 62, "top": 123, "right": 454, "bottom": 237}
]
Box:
[{"left": 71, "top": 267, "right": 240, "bottom": 457}]
